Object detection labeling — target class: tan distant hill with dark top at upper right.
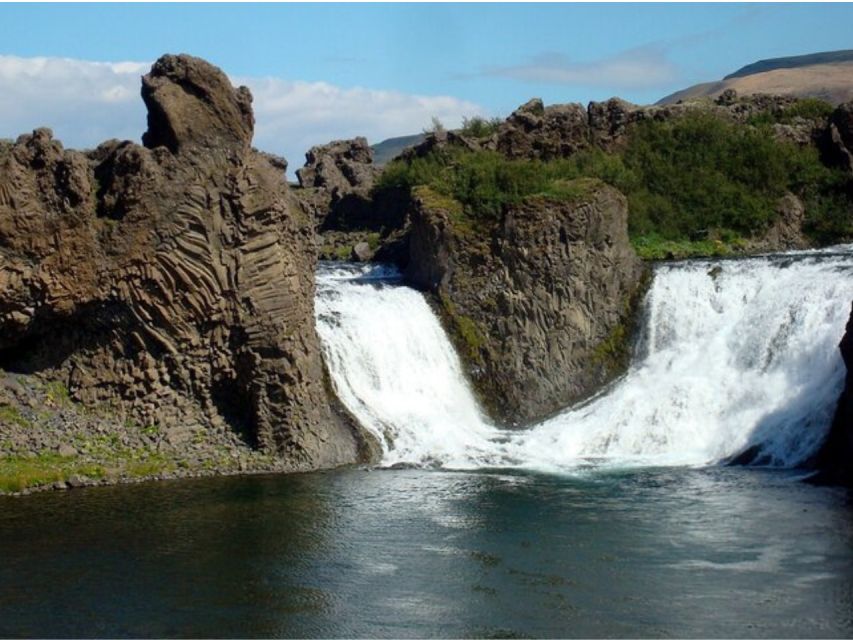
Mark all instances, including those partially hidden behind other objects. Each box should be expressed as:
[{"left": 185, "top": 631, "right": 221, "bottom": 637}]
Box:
[{"left": 657, "top": 50, "right": 853, "bottom": 104}]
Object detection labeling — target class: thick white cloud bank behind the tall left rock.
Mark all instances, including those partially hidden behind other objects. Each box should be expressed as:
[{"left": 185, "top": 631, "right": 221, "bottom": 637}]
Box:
[{"left": 0, "top": 56, "right": 485, "bottom": 169}]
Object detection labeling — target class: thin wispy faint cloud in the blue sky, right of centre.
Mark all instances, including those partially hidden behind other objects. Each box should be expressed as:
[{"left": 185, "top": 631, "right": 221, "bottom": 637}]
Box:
[{"left": 483, "top": 47, "right": 678, "bottom": 90}]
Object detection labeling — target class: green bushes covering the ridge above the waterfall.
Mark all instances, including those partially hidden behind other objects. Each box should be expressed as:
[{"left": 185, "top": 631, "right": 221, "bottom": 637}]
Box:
[{"left": 376, "top": 105, "right": 853, "bottom": 258}]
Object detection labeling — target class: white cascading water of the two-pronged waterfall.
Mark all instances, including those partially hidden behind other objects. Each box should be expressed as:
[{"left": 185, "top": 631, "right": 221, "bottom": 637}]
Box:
[{"left": 316, "top": 247, "right": 853, "bottom": 471}]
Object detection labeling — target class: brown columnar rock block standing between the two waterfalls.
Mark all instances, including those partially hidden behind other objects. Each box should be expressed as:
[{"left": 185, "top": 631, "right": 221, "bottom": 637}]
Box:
[{"left": 405, "top": 181, "right": 643, "bottom": 422}]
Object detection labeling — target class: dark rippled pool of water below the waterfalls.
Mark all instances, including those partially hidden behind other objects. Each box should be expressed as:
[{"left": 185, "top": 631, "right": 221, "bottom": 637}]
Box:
[{"left": 0, "top": 469, "right": 853, "bottom": 637}]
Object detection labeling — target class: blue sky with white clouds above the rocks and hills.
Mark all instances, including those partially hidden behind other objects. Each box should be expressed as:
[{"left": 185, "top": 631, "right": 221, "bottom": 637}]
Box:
[{"left": 0, "top": 3, "right": 853, "bottom": 170}]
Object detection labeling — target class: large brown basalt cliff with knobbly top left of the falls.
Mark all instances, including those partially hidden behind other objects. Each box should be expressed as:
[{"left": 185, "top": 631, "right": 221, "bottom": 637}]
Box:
[{"left": 0, "top": 55, "right": 372, "bottom": 468}]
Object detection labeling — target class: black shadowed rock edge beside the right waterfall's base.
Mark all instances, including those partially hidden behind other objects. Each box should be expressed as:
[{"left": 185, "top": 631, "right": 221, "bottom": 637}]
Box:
[{"left": 815, "top": 307, "right": 853, "bottom": 486}]
